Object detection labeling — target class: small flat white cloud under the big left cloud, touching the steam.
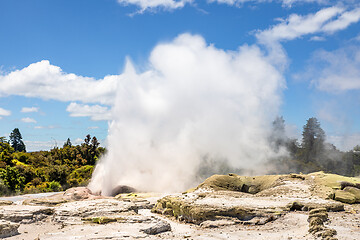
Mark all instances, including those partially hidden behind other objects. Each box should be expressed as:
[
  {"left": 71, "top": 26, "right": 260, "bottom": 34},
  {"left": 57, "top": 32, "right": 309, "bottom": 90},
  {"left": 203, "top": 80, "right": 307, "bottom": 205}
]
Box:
[{"left": 66, "top": 102, "right": 111, "bottom": 121}]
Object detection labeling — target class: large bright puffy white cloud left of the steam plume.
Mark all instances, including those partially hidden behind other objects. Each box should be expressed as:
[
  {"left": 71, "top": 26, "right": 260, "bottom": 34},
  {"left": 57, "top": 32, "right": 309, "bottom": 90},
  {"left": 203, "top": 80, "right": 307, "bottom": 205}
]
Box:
[{"left": 0, "top": 60, "right": 120, "bottom": 104}]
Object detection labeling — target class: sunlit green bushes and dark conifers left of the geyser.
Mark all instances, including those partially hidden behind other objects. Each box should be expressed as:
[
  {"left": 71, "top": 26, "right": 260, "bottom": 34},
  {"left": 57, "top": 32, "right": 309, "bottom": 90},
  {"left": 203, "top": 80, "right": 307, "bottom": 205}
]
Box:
[{"left": 0, "top": 128, "right": 106, "bottom": 195}]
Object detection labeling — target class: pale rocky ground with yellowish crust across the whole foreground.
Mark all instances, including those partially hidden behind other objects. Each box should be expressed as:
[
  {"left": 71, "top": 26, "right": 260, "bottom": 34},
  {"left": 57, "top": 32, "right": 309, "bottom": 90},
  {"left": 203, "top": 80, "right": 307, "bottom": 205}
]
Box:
[{"left": 0, "top": 172, "right": 360, "bottom": 240}]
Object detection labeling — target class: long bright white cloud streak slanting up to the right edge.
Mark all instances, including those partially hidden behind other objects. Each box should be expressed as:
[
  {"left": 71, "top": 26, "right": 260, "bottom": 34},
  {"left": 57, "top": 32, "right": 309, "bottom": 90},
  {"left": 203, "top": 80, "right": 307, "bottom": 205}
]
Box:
[{"left": 256, "top": 6, "right": 360, "bottom": 45}]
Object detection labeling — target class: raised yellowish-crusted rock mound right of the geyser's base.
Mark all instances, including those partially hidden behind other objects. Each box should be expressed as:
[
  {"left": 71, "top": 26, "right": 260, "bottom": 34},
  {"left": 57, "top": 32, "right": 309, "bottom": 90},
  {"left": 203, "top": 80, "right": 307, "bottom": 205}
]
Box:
[{"left": 152, "top": 172, "right": 360, "bottom": 225}]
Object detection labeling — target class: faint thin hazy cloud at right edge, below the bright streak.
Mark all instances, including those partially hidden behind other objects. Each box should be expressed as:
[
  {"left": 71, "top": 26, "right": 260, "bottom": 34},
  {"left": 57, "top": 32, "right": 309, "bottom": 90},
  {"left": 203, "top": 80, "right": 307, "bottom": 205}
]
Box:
[{"left": 306, "top": 46, "right": 360, "bottom": 93}]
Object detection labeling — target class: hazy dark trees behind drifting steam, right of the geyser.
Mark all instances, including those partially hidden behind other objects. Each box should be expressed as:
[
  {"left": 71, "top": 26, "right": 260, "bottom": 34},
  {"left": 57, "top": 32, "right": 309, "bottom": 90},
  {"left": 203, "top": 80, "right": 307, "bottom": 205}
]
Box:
[{"left": 269, "top": 117, "right": 360, "bottom": 176}]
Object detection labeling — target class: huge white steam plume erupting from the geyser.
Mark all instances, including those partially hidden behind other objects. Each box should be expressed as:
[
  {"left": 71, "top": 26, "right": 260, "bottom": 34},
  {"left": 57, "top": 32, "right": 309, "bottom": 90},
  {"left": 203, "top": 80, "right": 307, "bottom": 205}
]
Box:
[{"left": 89, "top": 34, "right": 284, "bottom": 195}]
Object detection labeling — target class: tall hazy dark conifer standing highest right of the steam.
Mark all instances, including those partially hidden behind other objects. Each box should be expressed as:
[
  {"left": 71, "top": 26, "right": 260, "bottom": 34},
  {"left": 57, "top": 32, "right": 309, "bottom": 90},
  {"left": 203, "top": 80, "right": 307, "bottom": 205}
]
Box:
[{"left": 301, "top": 117, "right": 325, "bottom": 162}]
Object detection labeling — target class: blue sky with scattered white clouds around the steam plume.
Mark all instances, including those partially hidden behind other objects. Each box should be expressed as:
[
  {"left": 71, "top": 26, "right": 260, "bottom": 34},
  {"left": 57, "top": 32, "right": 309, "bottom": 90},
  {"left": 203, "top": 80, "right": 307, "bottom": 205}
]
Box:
[{"left": 0, "top": 0, "right": 360, "bottom": 151}]
